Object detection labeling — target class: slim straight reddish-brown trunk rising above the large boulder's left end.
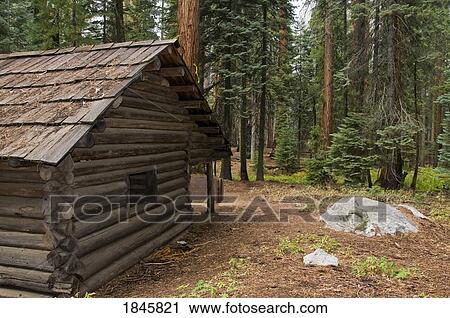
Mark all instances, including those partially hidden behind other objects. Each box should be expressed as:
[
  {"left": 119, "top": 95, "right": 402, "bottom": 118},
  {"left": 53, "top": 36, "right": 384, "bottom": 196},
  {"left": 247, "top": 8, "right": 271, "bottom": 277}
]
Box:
[{"left": 322, "top": 3, "right": 333, "bottom": 149}]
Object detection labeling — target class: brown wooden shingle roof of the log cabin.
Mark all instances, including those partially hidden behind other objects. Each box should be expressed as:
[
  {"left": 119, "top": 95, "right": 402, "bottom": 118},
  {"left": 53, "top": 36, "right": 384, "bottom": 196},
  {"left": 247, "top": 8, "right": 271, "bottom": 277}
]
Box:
[{"left": 0, "top": 40, "right": 227, "bottom": 164}]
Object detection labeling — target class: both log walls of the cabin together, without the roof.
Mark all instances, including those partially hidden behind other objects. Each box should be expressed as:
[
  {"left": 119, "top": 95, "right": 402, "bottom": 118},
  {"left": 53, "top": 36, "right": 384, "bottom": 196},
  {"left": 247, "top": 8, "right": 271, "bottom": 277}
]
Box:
[{"left": 0, "top": 76, "right": 214, "bottom": 296}]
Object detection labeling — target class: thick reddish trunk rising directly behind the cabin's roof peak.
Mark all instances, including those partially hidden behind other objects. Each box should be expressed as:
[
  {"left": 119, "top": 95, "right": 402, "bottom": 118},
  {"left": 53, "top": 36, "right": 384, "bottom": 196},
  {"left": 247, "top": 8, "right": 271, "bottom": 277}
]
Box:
[{"left": 178, "top": 0, "right": 200, "bottom": 81}]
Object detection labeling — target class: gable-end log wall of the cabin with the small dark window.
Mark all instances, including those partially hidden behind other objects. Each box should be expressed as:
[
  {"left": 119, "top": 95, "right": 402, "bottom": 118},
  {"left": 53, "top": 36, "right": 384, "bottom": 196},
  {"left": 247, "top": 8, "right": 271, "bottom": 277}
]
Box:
[{"left": 72, "top": 81, "right": 210, "bottom": 292}]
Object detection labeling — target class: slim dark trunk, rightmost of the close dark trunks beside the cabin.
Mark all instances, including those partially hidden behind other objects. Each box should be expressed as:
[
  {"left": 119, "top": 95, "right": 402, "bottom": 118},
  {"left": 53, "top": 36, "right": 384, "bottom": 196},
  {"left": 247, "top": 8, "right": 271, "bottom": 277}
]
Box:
[{"left": 256, "top": 2, "right": 268, "bottom": 181}]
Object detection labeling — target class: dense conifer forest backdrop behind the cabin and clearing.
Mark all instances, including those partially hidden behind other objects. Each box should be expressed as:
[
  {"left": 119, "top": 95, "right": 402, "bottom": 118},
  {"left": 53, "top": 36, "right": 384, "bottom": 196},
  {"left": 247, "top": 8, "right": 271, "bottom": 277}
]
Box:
[{"left": 0, "top": 0, "right": 450, "bottom": 189}]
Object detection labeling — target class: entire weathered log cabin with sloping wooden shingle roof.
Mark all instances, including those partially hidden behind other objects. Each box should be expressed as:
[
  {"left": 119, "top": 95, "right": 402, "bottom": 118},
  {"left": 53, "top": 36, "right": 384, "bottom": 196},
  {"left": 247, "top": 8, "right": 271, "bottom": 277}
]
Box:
[{"left": 0, "top": 40, "right": 231, "bottom": 297}]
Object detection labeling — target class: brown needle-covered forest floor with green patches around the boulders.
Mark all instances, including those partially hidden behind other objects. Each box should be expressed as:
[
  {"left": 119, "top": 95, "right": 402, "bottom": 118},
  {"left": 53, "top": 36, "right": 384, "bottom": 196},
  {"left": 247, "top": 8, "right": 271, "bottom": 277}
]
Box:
[{"left": 95, "top": 150, "right": 450, "bottom": 298}]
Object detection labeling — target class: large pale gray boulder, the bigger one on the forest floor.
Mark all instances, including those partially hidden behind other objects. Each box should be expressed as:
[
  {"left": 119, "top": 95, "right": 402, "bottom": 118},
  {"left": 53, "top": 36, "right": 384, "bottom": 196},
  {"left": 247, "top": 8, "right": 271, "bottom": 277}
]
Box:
[{"left": 320, "top": 197, "right": 417, "bottom": 237}]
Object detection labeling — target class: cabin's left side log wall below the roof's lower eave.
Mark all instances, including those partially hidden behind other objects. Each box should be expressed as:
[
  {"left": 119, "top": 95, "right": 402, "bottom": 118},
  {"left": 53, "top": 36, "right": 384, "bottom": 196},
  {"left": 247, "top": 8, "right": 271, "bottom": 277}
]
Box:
[{"left": 0, "top": 161, "right": 73, "bottom": 297}]
